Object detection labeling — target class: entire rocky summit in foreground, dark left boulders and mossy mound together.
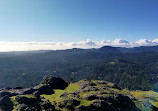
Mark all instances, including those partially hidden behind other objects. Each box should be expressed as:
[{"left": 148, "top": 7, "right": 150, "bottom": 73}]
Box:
[{"left": 0, "top": 76, "right": 144, "bottom": 111}]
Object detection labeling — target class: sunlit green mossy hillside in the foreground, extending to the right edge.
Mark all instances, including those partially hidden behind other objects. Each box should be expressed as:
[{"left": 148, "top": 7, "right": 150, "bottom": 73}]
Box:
[{"left": 4, "top": 80, "right": 158, "bottom": 111}]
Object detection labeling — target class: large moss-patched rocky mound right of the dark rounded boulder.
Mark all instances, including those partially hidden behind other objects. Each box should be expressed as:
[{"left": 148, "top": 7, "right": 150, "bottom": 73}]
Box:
[{"left": 48, "top": 80, "right": 139, "bottom": 111}]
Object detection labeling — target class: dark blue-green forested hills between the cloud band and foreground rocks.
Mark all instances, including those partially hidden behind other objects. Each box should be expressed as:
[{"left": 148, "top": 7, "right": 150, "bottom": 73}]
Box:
[{"left": 0, "top": 46, "right": 158, "bottom": 90}]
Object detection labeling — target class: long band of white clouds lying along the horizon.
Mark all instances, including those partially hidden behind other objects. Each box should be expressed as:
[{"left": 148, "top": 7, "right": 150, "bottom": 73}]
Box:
[{"left": 0, "top": 38, "right": 158, "bottom": 52}]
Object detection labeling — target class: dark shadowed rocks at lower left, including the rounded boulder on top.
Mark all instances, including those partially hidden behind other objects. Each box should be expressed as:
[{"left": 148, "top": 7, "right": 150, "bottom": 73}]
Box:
[{"left": 0, "top": 76, "right": 68, "bottom": 111}]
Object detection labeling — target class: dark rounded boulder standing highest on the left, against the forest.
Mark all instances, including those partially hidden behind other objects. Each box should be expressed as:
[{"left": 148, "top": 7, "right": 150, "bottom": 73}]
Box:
[{"left": 41, "top": 76, "right": 68, "bottom": 89}]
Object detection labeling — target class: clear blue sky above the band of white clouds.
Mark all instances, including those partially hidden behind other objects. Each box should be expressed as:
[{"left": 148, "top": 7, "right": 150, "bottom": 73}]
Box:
[{"left": 0, "top": 0, "right": 158, "bottom": 42}]
